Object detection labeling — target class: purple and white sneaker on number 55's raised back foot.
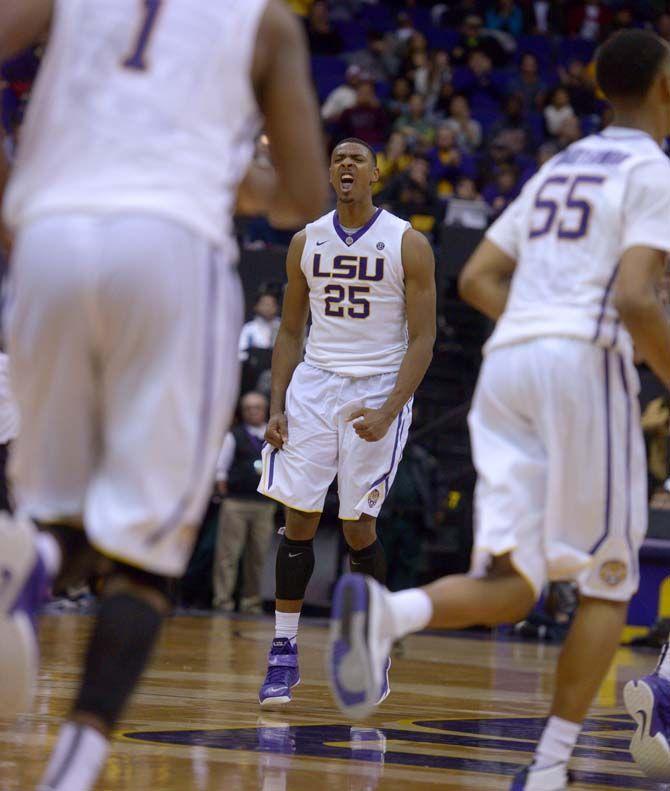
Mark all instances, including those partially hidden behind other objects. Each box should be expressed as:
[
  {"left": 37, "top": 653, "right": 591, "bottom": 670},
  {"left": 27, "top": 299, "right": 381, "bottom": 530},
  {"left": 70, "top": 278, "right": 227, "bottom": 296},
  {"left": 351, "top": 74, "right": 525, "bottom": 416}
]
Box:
[{"left": 328, "top": 574, "right": 392, "bottom": 719}]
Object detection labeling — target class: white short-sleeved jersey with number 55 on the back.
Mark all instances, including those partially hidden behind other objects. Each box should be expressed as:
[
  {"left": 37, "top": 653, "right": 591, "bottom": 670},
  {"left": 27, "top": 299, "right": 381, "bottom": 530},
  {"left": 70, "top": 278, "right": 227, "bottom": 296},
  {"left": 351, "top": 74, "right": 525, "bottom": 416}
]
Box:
[{"left": 486, "top": 127, "right": 670, "bottom": 356}]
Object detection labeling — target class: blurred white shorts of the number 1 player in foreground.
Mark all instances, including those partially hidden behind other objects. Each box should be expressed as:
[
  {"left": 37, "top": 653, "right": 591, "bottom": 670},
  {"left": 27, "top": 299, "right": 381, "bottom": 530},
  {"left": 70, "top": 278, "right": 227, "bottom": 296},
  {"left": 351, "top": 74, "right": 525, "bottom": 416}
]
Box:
[{"left": 6, "top": 214, "right": 243, "bottom": 576}]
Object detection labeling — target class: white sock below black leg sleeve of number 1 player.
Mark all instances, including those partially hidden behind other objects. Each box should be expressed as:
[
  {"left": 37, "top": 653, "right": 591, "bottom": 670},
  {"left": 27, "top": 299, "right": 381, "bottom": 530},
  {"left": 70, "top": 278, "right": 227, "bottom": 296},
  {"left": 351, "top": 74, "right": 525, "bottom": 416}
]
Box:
[{"left": 38, "top": 722, "right": 109, "bottom": 791}]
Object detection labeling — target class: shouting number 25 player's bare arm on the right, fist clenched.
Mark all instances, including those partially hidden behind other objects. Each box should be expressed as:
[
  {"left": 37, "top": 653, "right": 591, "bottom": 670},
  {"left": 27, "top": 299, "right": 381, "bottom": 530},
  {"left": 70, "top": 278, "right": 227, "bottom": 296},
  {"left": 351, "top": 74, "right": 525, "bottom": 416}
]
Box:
[{"left": 349, "top": 230, "right": 436, "bottom": 442}]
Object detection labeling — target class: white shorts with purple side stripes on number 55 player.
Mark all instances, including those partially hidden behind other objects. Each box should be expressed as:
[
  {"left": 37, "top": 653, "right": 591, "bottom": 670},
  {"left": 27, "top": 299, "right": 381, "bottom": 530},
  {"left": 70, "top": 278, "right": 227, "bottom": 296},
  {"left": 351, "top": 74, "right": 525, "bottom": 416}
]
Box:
[{"left": 469, "top": 338, "right": 647, "bottom": 601}]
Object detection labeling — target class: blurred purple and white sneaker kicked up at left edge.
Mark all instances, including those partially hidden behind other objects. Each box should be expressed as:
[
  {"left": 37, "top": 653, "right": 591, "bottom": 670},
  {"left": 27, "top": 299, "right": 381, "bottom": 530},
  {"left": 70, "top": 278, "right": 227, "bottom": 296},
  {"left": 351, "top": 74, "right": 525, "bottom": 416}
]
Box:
[{"left": 0, "top": 512, "right": 50, "bottom": 718}]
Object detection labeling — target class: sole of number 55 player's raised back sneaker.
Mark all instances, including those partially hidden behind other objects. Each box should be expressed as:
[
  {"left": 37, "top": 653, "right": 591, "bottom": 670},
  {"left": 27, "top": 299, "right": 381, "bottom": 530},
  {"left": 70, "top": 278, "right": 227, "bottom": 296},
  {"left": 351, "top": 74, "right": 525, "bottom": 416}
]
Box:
[{"left": 328, "top": 574, "right": 381, "bottom": 719}]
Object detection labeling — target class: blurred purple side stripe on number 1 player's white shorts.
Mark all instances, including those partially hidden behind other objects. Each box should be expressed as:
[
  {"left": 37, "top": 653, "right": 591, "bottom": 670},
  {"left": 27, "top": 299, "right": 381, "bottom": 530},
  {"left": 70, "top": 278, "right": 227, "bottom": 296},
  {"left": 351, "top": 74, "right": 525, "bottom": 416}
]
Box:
[{"left": 147, "top": 247, "right": 220, "bottom": 546}]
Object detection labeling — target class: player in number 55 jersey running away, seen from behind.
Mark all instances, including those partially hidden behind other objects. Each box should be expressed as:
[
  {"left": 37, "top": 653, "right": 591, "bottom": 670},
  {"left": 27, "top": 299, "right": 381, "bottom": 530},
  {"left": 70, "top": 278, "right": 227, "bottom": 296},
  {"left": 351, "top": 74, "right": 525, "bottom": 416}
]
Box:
[{"left": 330, "top": 30, "right": 670, "bottom": 791}]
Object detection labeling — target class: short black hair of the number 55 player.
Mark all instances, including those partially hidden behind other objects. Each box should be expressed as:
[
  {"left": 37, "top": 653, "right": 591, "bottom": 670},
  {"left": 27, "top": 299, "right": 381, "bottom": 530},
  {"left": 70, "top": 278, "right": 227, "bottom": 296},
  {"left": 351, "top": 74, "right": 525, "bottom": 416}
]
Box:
[{"left": 596, "top": 30, "right": 670, "bottom": 101}]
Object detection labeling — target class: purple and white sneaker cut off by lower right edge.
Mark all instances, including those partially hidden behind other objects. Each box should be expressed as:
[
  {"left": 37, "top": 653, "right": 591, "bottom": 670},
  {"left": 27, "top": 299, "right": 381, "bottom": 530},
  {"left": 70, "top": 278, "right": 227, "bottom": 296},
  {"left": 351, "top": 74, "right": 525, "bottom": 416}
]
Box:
[{"left": 623, "top": 673, "right": 670, "bottom": 783}]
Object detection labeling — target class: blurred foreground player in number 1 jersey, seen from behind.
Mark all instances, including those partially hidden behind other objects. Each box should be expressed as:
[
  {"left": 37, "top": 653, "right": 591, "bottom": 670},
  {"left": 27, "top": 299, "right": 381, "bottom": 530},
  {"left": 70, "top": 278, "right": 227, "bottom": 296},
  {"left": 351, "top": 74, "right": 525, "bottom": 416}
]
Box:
[{"left": 0, "top": 0, "right": 327, "bottom": 791}]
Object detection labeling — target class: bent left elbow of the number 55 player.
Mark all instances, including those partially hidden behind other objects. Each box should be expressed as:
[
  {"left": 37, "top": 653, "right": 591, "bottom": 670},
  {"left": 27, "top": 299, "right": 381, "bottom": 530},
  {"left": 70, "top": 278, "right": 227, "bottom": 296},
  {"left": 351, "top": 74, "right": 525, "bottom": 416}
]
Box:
[{"left": 458, "top": 239, "right": 516, "bottom": 321}]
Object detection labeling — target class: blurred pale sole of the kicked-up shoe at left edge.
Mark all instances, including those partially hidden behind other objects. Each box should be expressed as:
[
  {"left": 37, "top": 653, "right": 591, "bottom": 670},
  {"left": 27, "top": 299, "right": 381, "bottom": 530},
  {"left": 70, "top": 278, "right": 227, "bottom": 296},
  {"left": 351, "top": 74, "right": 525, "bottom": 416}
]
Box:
[{"left": 0, "top": 513, "right": 38, "bottom": 719}]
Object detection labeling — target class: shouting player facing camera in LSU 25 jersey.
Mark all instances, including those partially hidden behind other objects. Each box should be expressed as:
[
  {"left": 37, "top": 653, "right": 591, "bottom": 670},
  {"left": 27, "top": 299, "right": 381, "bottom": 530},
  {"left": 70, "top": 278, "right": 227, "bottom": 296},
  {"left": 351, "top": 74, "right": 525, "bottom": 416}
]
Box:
[{"left": 258, "top": 139, "right": 435, "bottom": 706}]
